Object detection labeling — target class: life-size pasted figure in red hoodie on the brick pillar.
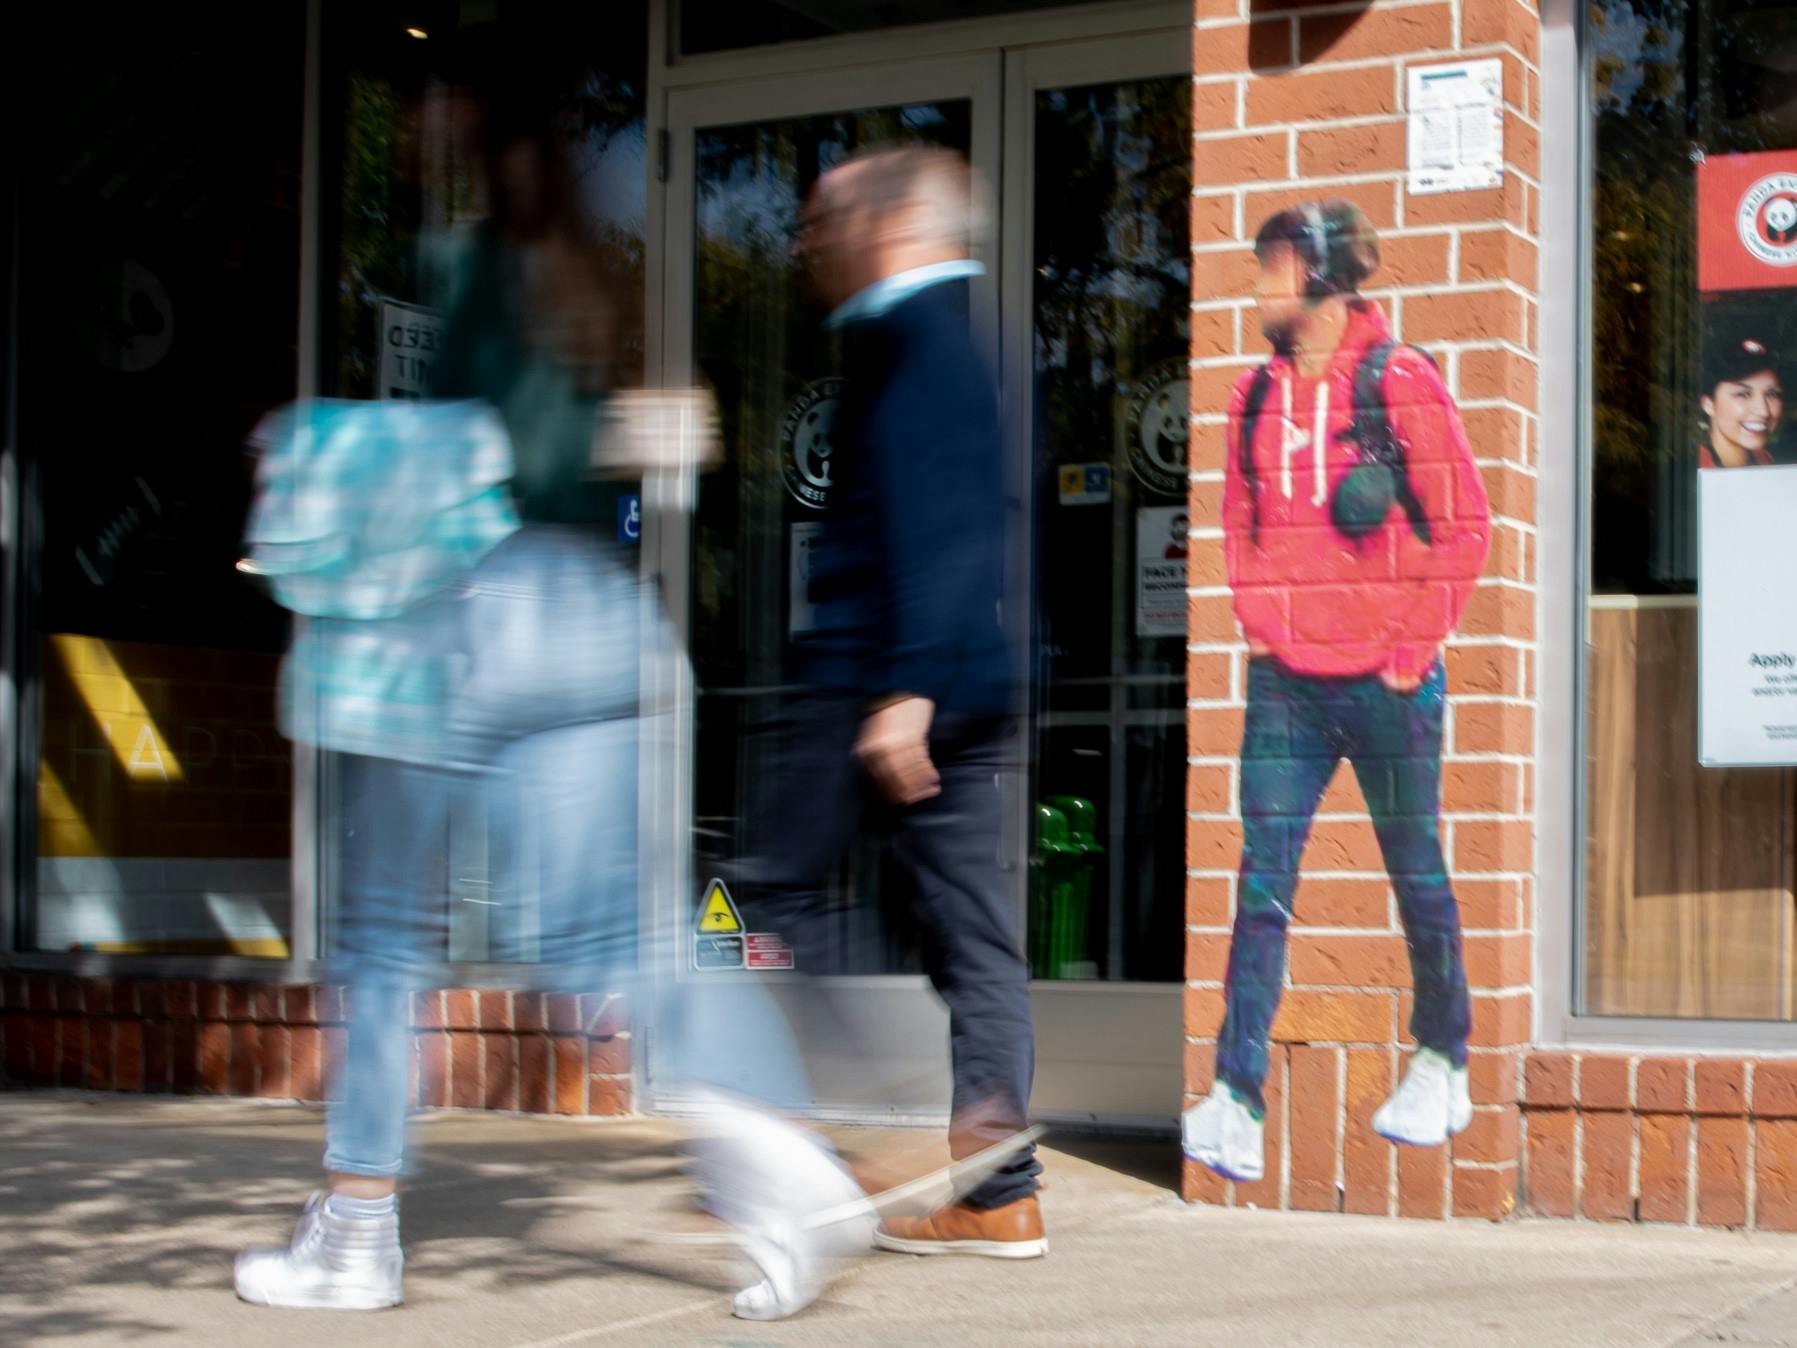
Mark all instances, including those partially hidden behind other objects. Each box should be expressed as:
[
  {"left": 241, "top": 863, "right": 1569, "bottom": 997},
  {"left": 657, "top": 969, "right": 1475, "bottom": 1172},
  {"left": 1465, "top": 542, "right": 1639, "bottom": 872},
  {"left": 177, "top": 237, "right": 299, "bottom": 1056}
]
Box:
[{"left": 1182, "top": 201, "right": 1490, "bottom": 1181}]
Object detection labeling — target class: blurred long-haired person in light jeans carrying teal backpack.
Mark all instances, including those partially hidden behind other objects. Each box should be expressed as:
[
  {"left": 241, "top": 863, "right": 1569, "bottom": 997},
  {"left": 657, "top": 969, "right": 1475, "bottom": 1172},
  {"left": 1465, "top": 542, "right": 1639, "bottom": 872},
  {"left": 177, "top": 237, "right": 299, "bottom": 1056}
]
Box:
[{"left": 235, "top": 31, "right": 658, "bottom": 1310}]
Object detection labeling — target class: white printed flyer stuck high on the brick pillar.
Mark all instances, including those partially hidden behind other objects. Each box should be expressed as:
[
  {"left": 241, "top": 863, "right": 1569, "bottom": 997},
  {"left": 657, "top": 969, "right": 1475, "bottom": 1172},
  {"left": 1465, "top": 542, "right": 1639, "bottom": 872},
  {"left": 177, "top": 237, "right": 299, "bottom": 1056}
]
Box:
[{"left": 1405, "top": 58, "right": 1504, "bottom": 196}]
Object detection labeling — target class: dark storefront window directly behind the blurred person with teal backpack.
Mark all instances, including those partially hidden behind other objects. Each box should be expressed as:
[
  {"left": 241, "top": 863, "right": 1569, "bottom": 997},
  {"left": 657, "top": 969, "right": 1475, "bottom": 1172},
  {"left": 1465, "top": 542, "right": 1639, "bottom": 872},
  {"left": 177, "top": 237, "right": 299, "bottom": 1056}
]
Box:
[{"left": 316, "top": 0, "right": 649, "bottom": 963}]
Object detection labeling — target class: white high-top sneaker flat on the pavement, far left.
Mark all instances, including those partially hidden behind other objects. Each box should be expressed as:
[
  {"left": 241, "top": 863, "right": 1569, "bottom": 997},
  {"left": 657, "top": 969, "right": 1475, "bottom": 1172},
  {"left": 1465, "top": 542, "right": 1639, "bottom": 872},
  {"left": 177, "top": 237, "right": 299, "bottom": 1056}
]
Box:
[{"left": 237, "top": 1192, "right": 404, "bottom": 1310}]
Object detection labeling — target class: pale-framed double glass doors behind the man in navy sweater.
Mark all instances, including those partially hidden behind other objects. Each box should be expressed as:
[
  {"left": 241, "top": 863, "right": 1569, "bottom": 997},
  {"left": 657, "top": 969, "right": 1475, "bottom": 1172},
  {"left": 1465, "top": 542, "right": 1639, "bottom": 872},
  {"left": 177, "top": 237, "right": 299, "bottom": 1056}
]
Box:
[{"left": 643, "top": 27, "right": 1191, "bottom": 1123}]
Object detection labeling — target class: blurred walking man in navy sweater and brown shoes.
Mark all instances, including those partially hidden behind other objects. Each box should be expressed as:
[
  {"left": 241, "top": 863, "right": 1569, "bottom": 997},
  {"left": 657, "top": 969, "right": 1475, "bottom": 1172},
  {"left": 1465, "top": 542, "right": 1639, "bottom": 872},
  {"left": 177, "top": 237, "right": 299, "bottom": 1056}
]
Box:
[{"left": 693, "top": 147, "right": 1048, "bottom": 1317}]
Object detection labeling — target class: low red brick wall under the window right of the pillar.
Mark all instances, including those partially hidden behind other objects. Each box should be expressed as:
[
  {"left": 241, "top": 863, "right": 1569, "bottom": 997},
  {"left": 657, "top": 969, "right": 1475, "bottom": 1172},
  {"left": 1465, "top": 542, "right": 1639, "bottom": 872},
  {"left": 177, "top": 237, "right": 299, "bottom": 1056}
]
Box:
[{"left": 1522, "top": 1051, "right": 1797, "bottom": 1231}]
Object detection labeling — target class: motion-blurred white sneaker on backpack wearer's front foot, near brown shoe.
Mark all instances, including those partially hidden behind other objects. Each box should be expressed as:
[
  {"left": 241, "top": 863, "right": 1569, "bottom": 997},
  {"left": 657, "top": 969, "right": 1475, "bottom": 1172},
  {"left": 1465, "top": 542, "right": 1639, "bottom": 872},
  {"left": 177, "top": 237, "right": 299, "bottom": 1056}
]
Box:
[{"left": 688, "top": 1093, "right": 875, "bottom": 1319}]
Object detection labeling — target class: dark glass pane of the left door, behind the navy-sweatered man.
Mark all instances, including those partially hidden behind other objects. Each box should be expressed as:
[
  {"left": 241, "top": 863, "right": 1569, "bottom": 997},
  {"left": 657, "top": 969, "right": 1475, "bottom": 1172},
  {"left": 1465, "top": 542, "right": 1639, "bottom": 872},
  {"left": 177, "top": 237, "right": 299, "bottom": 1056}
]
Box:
[{"left": 692, "top": 101, "right": 972, "bottom": 974}]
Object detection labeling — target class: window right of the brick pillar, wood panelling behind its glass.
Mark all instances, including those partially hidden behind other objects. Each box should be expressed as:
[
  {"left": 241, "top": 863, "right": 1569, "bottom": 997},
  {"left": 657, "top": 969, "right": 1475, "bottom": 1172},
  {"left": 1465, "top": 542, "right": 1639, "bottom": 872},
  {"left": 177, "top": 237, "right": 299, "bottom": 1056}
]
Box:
[{"left": 1580, "top": 0, "right": 1797, "bottom": 1019}]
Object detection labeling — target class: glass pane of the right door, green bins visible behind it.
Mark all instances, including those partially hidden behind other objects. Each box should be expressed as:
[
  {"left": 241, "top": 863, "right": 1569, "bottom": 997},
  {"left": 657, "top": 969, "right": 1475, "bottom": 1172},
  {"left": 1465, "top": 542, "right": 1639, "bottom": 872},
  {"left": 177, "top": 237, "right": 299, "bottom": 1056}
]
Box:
[{"left": 1031, "top": 77, "right": 1191, "bottom": 981}]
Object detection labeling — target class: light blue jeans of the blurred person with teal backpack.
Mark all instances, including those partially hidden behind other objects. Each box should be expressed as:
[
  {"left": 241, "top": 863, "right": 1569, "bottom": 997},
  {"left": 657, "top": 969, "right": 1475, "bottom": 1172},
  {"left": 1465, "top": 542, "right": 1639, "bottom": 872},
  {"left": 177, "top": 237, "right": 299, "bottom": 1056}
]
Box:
[{"left": 325, "top": 530, "right": 643, "bottom": 1175}]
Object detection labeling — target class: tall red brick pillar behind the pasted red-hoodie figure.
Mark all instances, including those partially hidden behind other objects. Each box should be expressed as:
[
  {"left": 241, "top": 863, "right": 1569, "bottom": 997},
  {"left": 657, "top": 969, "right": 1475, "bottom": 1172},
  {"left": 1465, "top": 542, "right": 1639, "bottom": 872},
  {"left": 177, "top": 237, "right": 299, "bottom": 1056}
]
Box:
[{"left": 1184, "top": 0, "right": 1540, "bottom": 1219}]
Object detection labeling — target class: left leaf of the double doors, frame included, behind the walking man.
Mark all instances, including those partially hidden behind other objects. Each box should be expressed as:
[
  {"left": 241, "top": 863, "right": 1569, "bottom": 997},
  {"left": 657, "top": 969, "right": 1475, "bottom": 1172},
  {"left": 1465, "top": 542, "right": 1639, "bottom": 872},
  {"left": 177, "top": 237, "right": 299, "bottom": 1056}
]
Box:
[{"left": 645, "top": 56, "right": 1022, "bottom": 1114}]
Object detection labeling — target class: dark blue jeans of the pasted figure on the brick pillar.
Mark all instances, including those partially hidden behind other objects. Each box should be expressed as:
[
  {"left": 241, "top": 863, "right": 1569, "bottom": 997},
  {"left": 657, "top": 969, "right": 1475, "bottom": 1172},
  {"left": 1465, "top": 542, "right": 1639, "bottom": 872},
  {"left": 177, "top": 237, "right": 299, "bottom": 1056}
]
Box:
[{"left": 1217, "top": 660, "right": 1472, "bottom": 1111}]
